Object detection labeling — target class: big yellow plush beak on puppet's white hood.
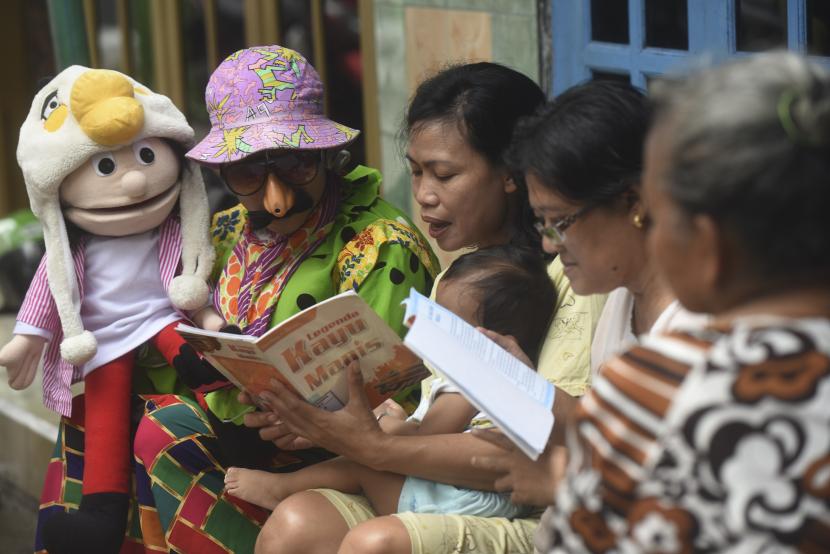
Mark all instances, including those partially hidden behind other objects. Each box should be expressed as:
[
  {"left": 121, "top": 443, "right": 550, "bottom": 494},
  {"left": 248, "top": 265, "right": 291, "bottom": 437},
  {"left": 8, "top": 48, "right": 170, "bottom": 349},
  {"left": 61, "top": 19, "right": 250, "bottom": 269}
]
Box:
[{"left": 70, "top": 69, "right": 144, "bottom": 146}]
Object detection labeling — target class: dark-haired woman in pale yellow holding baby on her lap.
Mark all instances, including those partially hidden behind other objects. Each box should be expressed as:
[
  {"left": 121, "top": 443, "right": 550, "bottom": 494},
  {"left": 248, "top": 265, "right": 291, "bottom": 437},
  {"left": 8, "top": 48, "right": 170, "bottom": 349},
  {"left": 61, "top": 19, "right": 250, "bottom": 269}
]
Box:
[{"left": 244, "top": 62, "right": 604, "bottom": 553}]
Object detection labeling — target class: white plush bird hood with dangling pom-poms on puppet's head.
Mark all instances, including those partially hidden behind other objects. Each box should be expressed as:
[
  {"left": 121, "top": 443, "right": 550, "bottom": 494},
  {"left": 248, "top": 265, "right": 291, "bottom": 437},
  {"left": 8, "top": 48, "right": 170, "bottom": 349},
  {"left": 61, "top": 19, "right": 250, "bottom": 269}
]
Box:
[{"left": 17, "top": 65, "right": 214, "bottom": 365}]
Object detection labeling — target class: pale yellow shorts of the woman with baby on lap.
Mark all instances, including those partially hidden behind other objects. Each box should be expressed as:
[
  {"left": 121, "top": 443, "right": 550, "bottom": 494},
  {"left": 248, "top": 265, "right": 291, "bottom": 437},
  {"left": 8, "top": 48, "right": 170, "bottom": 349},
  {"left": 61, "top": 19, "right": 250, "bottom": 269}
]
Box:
[{"left": 315, "top": 489, "right": 539, "bottom": 554}]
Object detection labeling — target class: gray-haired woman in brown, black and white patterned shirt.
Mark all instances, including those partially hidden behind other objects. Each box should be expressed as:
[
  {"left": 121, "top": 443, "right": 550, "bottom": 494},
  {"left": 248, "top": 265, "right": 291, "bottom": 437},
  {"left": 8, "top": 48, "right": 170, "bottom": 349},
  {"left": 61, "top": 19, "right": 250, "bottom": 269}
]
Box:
[{"left": 537, "top": 53, "right": 830, "bottom": 552}]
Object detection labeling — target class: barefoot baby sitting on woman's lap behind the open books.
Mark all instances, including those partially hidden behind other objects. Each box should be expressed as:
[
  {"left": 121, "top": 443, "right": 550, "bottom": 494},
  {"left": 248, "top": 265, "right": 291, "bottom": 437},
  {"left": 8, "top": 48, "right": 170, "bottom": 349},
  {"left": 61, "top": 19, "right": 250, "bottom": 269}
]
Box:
[{"left": 225, "top": 246, "right": 556, "bottom": 518}]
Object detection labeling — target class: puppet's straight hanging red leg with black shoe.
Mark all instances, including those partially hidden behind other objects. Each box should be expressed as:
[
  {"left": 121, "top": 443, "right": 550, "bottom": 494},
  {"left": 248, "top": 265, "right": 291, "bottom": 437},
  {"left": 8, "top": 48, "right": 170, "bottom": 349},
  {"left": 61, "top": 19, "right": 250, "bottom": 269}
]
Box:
[{"left": 42, "top": 352, "right": 134, "bottom": 554}]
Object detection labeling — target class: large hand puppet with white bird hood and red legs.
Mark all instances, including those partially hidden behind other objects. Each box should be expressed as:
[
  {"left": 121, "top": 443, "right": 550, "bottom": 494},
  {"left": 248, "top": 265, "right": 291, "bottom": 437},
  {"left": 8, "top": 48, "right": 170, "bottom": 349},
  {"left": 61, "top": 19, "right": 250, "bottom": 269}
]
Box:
[{"left": 0, "top": 66, "right": 224, "bottom": 553}]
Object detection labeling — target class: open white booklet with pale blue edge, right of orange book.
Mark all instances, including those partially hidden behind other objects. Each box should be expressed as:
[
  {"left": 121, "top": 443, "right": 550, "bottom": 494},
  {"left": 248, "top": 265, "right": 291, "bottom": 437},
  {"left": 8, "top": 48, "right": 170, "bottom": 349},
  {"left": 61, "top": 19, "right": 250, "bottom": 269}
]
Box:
[{"left": 404, "top": 289, "right": 555, "bottom": 460}]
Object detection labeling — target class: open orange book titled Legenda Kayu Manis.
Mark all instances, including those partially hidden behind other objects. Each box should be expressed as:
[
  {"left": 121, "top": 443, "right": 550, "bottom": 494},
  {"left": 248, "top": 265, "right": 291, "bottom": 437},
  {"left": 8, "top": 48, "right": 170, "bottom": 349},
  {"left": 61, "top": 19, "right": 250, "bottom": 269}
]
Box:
[{"left": 176, "top": 291, "right": 429, "bottom": 410}]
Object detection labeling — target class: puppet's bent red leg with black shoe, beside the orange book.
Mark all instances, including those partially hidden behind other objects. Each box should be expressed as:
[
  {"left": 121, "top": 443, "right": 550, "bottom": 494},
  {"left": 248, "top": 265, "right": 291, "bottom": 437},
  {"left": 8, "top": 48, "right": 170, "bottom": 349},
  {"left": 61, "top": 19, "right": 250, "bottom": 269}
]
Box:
[{"left": 152, "top": 321, "right": 229, "bottom": 393}]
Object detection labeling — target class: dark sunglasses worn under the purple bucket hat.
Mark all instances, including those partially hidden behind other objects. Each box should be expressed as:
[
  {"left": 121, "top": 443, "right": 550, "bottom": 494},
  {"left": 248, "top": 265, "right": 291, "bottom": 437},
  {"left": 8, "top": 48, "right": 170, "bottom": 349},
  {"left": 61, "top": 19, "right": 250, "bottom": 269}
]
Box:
[{"left": 219, "top": 150, "right": 323, "bottom": 196}]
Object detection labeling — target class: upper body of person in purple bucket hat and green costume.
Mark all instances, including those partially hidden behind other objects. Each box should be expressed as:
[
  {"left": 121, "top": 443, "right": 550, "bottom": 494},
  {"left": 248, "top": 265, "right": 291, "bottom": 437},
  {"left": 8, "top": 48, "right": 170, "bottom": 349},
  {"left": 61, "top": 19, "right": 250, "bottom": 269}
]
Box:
[{"left": 186, "top": 45, "right": 439, "bottom": 470}]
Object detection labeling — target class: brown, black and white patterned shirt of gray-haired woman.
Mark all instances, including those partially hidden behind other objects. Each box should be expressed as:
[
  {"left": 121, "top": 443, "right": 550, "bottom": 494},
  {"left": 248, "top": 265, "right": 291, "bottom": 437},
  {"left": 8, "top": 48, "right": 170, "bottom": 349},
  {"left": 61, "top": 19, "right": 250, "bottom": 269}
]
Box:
[{"left": 537, "top": 318, "right": 830, "bottom": 553}]
